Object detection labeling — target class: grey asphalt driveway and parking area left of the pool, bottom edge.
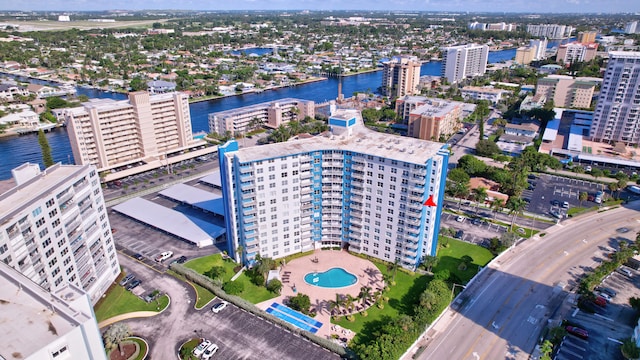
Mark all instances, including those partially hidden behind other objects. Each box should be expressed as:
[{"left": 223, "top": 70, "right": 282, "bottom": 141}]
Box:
[{"left": 113, "top": 254, "right": 339, "bottom": 360}]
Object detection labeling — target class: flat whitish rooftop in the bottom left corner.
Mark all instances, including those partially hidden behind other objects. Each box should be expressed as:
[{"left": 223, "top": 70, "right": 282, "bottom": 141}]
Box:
[{"left": 0, "top": 263, "right": 91, "bottom": 359}]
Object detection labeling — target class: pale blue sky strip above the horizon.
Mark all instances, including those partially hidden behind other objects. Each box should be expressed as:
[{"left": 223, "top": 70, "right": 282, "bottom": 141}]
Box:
[{"left": 0, "top": 0, "right": 640, "bottom": 14}]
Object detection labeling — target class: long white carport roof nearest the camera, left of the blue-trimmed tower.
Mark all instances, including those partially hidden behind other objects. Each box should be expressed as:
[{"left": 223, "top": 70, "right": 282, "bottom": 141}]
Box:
[{"left": 113, "top": 198, "right": 219, "bottom": 247}]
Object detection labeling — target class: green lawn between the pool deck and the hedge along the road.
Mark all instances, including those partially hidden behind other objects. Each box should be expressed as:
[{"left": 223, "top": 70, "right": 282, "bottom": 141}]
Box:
[{"left": 334, "top": 262, "right": 431, "bottom": 341}]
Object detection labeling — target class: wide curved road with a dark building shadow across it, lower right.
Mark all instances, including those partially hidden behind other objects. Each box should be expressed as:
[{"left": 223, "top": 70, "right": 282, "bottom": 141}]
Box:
[{"left": 412, "top": 202, "right": 640, "bottom": 360}]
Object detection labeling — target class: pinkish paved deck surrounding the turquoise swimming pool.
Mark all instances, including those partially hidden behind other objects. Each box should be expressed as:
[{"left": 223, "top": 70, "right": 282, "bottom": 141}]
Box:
[{"left": 257, "top": 250, "right": 384, "bottom": 340}]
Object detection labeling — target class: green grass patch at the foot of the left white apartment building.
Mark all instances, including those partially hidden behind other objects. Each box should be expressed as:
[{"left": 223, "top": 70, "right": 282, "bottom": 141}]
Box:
[{"left": 94, "top": 285, "right": 169, "bottom": 322}]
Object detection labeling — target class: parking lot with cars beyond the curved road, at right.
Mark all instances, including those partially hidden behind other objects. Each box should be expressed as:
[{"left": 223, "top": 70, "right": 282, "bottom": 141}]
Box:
[{"left": 522, "top": 174, "right": 603, "bottom": 215}]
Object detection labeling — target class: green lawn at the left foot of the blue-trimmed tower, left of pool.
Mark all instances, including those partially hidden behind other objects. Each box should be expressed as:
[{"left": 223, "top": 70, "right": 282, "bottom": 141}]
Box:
[{"left": 184, "top": 254, "right": 277, "bottom": 304}]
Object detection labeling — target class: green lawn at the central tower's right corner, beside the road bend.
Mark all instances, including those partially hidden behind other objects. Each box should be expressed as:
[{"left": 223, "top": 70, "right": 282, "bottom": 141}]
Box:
[{"left": 433, "top": 239, "right": 493, "bottom": 284}]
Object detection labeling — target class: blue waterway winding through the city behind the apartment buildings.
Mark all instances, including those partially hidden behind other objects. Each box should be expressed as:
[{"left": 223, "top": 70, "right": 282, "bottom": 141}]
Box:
[{"left": 0, "top": 49, "right": 516, "bottom": 180}]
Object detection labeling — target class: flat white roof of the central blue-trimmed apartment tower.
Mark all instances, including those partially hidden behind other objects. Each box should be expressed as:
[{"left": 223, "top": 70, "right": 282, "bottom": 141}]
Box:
[{"left": 229, "top": 111, "right": 446, "bottom": 165}]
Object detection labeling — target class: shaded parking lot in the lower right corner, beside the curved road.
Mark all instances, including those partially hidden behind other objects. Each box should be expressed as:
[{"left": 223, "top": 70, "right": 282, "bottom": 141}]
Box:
[{"left": 556, "top": 264, "right": 640, "bottom": 360}]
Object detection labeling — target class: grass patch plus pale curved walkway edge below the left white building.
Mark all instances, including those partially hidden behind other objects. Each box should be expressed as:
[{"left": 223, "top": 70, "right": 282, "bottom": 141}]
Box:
[{"left": 94, "top": 285, "right": 170, "bottom": 327}]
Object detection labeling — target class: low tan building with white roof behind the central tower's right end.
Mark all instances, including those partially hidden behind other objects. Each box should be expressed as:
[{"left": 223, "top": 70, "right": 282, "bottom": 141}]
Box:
[{"left": 396, "top": 96, "right": 464, "bottom": 141}]
